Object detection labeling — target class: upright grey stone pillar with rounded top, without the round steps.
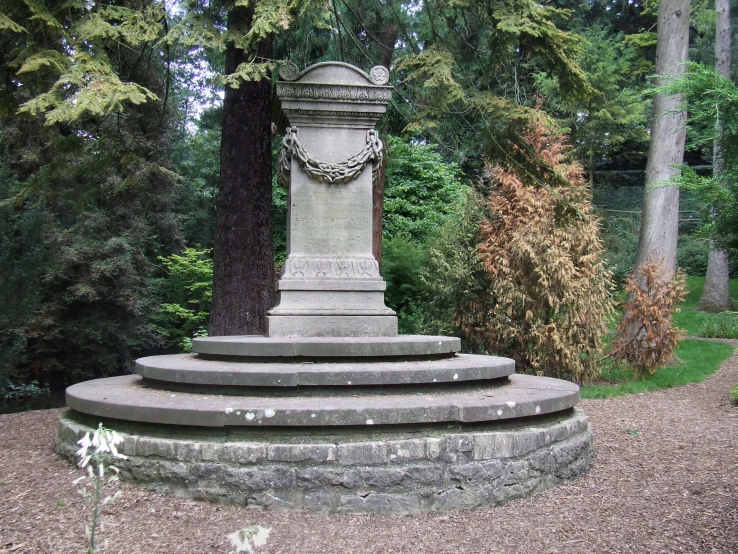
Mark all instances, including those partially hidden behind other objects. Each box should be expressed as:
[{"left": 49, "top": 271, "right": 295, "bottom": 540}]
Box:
[{"left": 267, "top": 63, "right": 397, "bottom": 337}]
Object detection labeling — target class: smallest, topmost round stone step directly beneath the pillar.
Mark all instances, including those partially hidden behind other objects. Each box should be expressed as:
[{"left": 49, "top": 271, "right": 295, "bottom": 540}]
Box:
[{"left": 192, "top": 335, "right": 461, "bottom": 358}]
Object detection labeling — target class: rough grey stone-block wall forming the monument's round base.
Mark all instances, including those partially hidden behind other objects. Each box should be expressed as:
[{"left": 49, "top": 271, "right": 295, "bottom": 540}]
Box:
[{"left": 57, "top": 409, "right": 593, "bottom": 513}]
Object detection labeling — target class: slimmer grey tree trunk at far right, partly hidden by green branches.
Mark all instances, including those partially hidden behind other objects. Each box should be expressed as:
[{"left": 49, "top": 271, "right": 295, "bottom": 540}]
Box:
[{"left": 697, "top": 0, "right": 733, "bottom": 312}]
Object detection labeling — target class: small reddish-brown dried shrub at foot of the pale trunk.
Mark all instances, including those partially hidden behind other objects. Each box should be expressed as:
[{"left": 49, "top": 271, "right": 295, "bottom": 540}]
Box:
[{"left": 610, "top": 260, "right": 686, "bottom": 377}]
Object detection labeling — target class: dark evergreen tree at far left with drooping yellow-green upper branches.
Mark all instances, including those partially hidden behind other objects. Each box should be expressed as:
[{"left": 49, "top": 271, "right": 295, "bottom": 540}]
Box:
[{"left": 0, "top": 2, "right": 178, "bottom": 390}]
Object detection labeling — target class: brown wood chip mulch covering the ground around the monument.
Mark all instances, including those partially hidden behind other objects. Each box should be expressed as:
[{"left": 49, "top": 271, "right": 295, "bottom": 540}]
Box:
[{"left": 0, "top": 344, "right": 738, "bottom": 554}]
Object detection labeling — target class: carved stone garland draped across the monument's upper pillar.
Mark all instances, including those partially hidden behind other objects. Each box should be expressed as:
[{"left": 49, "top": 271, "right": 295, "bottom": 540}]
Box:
[{"left": 279, "top": 127, "right": 384, "bottom": 186}]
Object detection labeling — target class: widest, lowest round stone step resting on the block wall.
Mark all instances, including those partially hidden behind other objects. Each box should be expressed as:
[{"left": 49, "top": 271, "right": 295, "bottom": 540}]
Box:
[{"left": 67, "top": 375, "right": 579, "bottom": 427}]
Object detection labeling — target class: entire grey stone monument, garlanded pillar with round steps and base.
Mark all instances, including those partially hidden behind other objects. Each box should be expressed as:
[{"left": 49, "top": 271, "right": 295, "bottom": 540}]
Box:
[{"left": 57, "top": 62, "right": 592, "bottom": 513}]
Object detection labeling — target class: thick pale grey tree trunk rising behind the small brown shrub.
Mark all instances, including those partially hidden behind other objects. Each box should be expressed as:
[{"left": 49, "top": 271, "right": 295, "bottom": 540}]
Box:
[{"left": 635, "top": 0, "right": 689, "bottom": 278}]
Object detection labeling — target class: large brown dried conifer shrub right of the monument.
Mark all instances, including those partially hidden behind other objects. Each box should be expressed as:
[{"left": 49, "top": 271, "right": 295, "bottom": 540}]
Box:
[{"left": 456, "top": 124, "right": 613, "bottom": 382}]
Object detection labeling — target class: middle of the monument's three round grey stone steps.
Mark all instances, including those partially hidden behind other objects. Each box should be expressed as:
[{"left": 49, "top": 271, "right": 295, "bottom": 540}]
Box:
[{"left": 136, "top": 354, "right": 515, "bottom": 387}]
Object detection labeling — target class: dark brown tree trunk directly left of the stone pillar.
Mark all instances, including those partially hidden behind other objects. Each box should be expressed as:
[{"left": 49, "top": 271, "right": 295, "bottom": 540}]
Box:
[{"left": 210, "top": 3, "right": 274, "bottom": 335}]
